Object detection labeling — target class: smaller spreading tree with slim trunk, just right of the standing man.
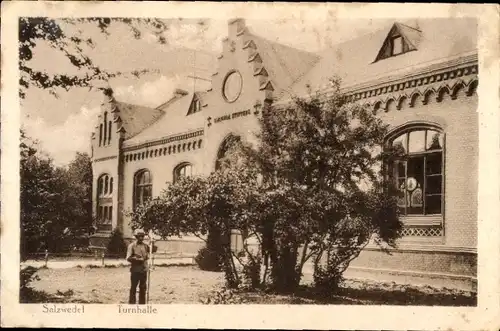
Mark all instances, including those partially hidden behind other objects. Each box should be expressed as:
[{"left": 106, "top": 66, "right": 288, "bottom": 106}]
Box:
[{"left": 129, "top": 165, "right": 257, "bottom": 287}]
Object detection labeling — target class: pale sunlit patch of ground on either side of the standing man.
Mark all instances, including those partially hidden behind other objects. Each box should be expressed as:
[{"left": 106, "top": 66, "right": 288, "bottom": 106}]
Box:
[{"left": 33, "top": 266, "right": 224, "bottom": 304}]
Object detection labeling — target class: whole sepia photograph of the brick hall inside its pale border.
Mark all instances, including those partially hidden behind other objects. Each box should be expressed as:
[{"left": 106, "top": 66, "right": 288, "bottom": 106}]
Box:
[{"left": 2, "top": 4, "right": 498, "bottom": 330}]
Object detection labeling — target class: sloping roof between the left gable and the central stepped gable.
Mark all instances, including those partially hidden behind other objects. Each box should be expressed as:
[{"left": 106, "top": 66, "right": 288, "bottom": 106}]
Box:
[{"left": 125, "top": 92, "right": 205, "bottom": 145}]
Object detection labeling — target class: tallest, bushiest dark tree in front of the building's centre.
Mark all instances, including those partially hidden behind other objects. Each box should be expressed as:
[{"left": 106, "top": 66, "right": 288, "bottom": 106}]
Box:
[{"left": 240, "top": 79, "right": 402, "bottom": 291}]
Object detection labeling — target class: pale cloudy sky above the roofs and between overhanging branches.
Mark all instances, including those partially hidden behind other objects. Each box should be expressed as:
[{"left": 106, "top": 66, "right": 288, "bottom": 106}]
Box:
[{"left": 21, "top": 17, "right": 393, "bottom": 166}]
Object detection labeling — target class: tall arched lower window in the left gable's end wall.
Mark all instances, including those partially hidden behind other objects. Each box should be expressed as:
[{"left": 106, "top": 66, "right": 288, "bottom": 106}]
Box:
[{"left": 97, "top": 174, "right": 113, "bottom": 231}]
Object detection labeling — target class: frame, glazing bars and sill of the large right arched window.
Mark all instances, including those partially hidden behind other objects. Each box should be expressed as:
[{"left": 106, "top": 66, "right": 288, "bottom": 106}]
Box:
[{"left": 385, "top": 123, "right": 446, "bottom": 228}]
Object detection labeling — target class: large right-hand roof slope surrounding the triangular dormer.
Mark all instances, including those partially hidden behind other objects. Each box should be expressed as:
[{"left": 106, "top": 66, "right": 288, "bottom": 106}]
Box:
[{"left": 290, "top": 18, "right": 477, "bottom": 95}]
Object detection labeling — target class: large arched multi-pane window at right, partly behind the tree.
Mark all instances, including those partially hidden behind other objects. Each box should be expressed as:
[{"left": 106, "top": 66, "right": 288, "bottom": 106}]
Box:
[{"left": 388, "top": 126, "right": 444, "bottom": 217}]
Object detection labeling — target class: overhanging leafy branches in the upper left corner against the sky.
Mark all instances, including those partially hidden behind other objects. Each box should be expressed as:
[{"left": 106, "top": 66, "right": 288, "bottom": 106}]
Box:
[{"left": 19, "top": 17, "right": 168, "bottom": 98}]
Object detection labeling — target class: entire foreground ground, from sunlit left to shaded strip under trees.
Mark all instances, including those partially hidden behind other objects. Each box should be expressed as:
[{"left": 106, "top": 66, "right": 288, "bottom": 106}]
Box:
[{"left": 24, "top": 265, "right": 477, "bottom": 306}]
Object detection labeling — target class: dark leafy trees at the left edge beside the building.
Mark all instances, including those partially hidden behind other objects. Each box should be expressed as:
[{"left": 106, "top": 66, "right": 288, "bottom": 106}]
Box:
[{"left": 20, "top": 132, "right": 92, "bottom": 259}]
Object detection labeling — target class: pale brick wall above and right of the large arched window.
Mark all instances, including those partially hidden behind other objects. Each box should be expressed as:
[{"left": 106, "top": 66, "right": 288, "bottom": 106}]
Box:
[{"left": 380, "top": 87, "right": 479, "bottom": 247}]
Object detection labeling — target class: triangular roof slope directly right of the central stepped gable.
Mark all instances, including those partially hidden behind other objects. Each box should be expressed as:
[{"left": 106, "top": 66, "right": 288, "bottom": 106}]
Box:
[{"left": 248, "top": 33, "right": 320, "bottom": 93}]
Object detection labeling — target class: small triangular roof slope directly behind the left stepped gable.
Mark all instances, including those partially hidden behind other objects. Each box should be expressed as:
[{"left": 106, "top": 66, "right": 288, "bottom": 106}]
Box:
[{"left": 115, "top": 101, "right": 164, "bottom": 139}]
